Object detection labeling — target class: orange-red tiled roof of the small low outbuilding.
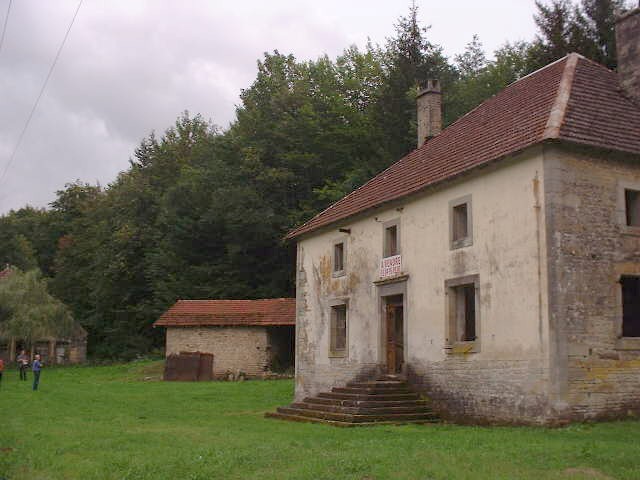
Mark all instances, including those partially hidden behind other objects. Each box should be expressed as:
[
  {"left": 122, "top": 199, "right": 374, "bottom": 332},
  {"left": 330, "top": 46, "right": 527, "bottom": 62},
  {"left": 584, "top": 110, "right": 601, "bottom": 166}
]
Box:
[{"left": 153, "top": 298, "right": 296, "bottom": 327}]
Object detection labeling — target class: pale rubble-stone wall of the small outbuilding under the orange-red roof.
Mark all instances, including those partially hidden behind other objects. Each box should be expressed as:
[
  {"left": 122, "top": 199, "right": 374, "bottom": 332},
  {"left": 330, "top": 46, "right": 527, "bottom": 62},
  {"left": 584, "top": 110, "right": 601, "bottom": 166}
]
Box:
[{"left": 166, "top": 326, "right": 270, "bottom": 377}]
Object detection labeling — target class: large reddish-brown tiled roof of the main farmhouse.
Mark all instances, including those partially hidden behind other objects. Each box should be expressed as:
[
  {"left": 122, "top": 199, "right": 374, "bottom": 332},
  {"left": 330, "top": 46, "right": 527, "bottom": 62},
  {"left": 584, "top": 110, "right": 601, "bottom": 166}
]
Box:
[{"left": 287, "top": 53, "right": 640, "bottom": 239}]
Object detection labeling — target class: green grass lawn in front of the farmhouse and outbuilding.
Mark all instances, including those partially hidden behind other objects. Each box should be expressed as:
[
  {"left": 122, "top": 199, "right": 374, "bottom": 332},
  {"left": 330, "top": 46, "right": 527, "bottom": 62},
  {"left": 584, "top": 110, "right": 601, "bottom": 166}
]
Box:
[{"left": 0, "top": 362, "right": 640, "bottom": 480}]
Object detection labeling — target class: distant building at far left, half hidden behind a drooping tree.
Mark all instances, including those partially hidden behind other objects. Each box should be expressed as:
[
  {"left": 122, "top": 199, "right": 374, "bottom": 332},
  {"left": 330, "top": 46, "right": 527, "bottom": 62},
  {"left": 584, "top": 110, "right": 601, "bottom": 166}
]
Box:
[{"left": 0, "top": 265, "right": 87, "bottom": 365}]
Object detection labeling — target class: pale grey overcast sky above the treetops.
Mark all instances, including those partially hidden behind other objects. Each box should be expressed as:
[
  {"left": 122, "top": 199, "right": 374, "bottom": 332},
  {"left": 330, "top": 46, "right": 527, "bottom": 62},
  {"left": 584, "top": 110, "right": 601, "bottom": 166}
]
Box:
[{"left": 0, "top": 0, "right": 535, "bottom": 213}]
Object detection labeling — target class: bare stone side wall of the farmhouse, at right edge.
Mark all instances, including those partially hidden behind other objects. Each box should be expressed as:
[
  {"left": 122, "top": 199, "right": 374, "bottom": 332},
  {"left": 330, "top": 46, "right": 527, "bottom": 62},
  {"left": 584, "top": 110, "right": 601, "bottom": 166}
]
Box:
[{"left": 545, "top": 147, "right": 640, "bottom": 419}]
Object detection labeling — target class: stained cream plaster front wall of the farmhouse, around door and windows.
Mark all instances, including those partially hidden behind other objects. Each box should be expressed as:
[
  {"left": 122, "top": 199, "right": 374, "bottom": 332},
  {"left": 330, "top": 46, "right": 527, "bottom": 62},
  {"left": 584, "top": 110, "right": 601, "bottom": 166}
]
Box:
[{"left": 296, "top": 148, "right": 550, "bottom": 422}]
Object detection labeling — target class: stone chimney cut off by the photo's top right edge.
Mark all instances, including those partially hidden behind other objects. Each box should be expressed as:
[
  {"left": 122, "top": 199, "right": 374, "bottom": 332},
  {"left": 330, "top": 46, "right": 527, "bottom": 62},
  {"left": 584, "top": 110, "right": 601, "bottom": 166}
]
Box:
[{"left": 616, "top": 6, "right": 640, "bottom": 104}]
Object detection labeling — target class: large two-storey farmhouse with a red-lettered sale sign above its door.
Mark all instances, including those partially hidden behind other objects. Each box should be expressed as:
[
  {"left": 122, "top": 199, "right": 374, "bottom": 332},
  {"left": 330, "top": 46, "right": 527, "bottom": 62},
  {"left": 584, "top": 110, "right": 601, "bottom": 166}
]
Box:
[{"left": 274, "top": 8, "right": 640, "bottom": 424}]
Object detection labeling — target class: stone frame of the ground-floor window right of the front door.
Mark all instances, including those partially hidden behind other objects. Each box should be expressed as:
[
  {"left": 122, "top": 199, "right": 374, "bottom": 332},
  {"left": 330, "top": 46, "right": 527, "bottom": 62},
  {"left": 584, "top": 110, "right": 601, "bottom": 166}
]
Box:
[{"left": 444, "top": 274, "right": 481, "bottom": 353}]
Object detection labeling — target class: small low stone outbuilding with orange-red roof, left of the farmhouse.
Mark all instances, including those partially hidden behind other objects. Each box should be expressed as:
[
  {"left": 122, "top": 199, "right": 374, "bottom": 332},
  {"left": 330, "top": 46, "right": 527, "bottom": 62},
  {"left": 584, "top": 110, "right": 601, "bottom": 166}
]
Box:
[{"left": 154, "top": 298, "right": 296, "bottom": 378}]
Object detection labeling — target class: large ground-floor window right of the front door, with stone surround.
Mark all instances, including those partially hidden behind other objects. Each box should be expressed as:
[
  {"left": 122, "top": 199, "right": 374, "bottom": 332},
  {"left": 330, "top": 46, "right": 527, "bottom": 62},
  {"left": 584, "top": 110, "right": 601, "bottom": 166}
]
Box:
[{"left": 445, "top": 275, "right": 480, "bottom": 353}]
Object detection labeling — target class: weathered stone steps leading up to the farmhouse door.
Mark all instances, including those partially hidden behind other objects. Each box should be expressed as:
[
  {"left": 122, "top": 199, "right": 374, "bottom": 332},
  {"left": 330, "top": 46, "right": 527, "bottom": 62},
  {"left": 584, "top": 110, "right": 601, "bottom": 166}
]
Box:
[{"left": 265, "top": 377, "right": 438, "bottom": 426}]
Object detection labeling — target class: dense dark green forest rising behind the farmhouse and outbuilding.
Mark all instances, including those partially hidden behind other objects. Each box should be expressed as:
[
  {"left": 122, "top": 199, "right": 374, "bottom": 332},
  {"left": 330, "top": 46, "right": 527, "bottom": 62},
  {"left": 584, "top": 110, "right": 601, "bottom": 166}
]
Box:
[{"left": 0, "top": 0, "right": 625, "bottom": 358}]
